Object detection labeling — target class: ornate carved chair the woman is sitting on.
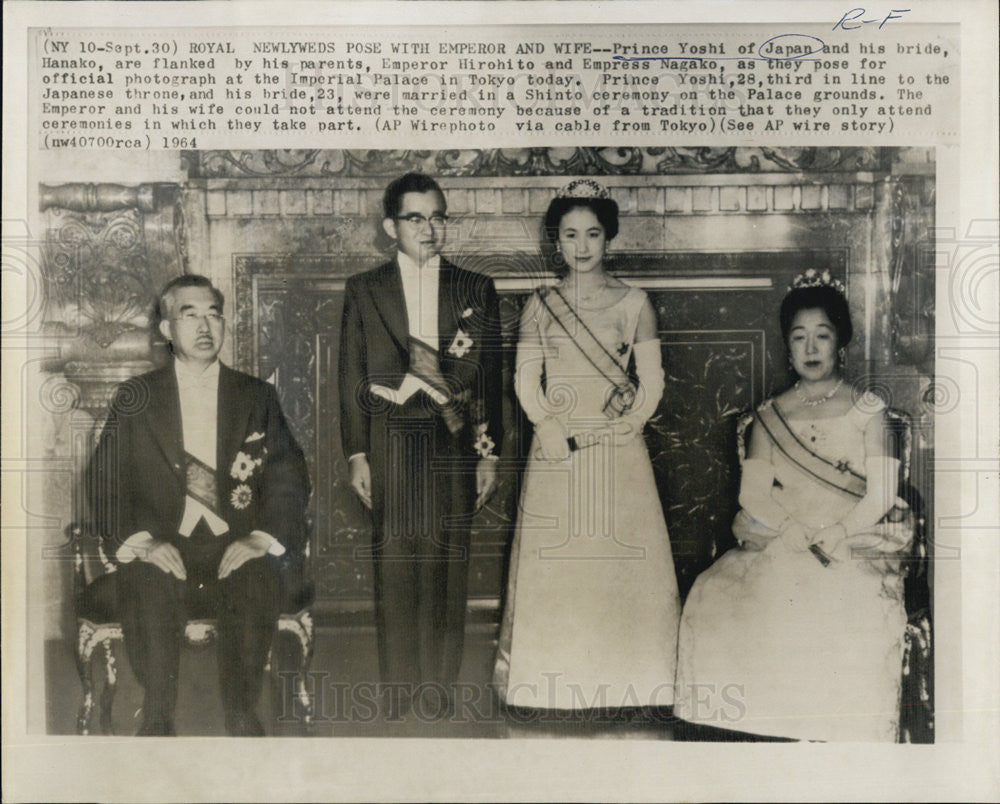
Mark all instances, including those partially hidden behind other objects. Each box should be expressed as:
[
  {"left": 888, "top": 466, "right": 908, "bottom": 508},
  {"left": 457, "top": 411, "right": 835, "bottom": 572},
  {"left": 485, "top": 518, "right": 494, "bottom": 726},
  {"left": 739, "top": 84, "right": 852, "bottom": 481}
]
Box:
[{"left": 736, "top": 408, "right": 934, "bottom": 743}]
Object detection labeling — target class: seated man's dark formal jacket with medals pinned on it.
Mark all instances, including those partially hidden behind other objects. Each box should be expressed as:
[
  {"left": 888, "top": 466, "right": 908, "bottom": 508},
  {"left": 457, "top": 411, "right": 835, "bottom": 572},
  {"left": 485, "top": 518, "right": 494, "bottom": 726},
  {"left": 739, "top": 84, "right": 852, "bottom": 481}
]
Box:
[{"left": 87, "top": 363, "right": 309, "bottom": 560}]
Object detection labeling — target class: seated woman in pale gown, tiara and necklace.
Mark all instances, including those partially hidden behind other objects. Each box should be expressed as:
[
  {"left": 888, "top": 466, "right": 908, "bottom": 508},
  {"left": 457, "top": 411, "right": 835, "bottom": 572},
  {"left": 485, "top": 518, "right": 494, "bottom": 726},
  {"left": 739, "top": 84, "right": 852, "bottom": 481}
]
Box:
[{"left": 674, "top": 271, "right": 913, "bottom": 741}]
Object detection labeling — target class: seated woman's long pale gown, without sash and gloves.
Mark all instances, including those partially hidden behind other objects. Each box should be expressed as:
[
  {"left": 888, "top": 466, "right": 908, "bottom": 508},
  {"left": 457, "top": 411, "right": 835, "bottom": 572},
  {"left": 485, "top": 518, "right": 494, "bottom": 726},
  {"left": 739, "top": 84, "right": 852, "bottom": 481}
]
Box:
[{"left": 674, "top": 408, "right": 906, "bottom": 742}]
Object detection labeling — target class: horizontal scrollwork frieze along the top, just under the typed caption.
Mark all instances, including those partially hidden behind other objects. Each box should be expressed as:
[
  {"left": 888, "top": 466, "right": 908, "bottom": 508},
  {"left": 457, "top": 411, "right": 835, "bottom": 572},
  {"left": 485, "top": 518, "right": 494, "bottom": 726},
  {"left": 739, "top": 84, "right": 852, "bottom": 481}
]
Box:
[{"left": 181, "top": 147, "right": 891, "bottom": 179}]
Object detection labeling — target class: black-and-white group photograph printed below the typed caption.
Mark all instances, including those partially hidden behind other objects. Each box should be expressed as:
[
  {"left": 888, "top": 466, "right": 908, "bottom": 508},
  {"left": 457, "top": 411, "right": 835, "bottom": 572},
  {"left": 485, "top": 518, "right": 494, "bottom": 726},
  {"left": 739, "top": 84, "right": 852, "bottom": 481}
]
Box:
[{"left": 31, "top": 147, "right": 939, "bottom": 742}]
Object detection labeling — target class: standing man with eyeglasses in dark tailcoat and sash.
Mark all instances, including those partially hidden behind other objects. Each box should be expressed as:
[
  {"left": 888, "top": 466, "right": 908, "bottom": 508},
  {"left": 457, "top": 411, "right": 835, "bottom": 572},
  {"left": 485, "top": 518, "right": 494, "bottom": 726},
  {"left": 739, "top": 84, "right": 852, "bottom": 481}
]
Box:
[{"left": 340, "top": 173, "right": 501, "bottom": 718}]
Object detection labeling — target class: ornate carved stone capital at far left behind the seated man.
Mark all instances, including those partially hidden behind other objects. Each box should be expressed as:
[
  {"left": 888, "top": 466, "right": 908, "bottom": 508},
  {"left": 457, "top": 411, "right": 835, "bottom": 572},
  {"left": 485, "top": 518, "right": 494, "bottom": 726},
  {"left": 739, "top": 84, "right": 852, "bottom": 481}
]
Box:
[{"left": 39, "top": 184, "right": 186, "bottom": 415}]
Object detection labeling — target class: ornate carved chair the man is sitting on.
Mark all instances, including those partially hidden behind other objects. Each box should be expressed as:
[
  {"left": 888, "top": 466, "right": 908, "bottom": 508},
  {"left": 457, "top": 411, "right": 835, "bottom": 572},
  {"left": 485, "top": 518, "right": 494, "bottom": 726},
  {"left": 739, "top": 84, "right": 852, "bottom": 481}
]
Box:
[{"left": 66, "top": 524, "right": 315, "bottom": 734}]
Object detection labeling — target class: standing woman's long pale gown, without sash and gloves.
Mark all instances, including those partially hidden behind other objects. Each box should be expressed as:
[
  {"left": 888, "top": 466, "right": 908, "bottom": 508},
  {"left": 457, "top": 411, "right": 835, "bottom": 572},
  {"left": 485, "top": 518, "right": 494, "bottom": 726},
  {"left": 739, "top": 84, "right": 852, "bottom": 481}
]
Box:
[{"left": 494, "top": 288, "right": 680, "bottom": 710}]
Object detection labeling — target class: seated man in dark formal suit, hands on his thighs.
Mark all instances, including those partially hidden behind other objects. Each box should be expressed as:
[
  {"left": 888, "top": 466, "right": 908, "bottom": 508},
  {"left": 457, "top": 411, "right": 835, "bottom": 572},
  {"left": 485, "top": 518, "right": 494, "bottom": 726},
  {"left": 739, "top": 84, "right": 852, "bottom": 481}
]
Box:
[{"left": 87, "top": 274, "right": 309, "bottom": 736}]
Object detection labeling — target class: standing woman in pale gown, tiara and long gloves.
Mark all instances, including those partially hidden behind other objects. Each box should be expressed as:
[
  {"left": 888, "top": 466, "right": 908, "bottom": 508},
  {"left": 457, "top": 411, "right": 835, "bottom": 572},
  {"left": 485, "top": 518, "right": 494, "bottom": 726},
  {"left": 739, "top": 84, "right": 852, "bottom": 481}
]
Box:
[{"left": 494, "top": 179, "right": 680, "bottom": 710}]
